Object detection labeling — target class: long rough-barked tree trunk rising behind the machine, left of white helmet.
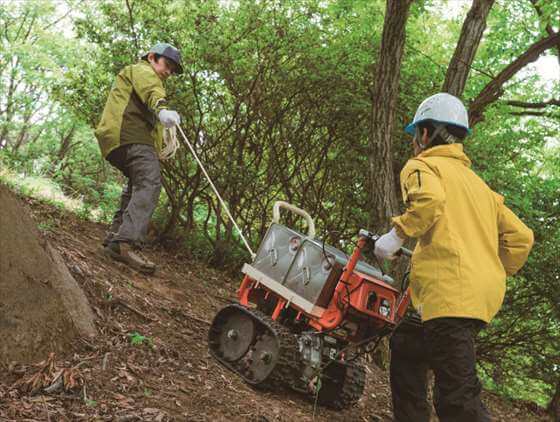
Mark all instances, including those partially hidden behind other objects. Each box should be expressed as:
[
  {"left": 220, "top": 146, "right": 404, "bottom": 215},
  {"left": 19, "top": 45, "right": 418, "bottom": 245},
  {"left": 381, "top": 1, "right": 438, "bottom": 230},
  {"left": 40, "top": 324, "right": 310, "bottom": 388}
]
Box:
[{"left": 369, "top": 0, "right": 413, "bottom": 231}]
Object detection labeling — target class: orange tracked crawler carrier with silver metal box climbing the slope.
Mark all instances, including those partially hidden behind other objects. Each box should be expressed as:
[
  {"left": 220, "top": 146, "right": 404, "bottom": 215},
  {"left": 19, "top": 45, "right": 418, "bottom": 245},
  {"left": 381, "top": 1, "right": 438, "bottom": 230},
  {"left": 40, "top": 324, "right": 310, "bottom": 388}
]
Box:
[{"left": 208, "top": 202, "right": 410, "bottom": 409}]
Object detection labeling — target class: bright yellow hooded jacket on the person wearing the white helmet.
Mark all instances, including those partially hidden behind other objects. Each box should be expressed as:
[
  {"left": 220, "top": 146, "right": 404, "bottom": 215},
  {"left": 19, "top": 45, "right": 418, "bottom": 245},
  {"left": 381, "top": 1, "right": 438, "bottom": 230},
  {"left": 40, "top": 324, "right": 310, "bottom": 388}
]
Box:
[{"left": 393, "top": 144, "right": 533, "bottom": 322}]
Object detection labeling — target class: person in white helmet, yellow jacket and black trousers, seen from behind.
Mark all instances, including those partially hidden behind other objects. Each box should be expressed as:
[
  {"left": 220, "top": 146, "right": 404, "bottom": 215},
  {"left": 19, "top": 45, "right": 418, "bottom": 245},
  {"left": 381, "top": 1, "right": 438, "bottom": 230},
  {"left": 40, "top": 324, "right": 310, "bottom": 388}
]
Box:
[{"left": 375, "top": 93, "right": 533, "bottom": 422}]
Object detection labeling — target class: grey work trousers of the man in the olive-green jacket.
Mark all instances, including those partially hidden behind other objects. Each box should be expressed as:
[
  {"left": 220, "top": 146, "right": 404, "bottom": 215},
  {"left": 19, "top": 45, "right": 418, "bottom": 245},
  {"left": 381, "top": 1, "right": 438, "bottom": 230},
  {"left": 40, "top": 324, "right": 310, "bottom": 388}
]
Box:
[{"left": 107, "top": 144, "right": 161, "bottom": 243}]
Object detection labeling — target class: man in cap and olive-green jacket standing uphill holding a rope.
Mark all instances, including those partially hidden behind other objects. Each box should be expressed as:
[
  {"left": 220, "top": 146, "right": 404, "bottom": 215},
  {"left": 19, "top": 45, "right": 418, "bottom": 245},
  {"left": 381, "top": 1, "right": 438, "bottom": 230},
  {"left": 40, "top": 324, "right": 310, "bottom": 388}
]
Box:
[{"left": 95, "top": 43, "right": 182, "bottom": 274}]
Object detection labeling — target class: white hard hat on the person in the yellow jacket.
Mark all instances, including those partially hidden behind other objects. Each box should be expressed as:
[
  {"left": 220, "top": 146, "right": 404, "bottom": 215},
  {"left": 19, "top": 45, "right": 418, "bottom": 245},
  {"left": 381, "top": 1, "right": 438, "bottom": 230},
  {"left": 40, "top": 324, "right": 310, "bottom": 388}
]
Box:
[{"left": 404, "top": 92, "right": 471, "bottom": 135}]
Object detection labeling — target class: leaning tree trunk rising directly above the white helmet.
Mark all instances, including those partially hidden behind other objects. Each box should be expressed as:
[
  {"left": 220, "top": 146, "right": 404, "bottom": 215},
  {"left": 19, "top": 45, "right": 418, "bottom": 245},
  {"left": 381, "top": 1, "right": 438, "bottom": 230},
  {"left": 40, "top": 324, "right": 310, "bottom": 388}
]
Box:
[{"left": 442, "top": 0, "right": 494, "bottom": 97}]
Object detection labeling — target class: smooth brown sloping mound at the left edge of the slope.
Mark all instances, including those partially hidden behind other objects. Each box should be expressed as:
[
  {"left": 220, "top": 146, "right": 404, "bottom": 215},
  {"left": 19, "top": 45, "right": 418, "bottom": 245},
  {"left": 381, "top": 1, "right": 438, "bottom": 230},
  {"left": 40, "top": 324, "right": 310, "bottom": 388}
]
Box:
[{"left": 0, "top": 184, "right": 96, "bottom": 363}]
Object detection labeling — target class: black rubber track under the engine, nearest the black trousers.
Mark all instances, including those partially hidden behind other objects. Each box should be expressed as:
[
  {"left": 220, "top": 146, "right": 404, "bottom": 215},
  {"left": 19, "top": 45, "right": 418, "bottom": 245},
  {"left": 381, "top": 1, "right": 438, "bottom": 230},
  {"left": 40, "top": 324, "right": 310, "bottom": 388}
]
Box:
[{"left": 318, "top": 361, "right": 366, "bottom": 410}]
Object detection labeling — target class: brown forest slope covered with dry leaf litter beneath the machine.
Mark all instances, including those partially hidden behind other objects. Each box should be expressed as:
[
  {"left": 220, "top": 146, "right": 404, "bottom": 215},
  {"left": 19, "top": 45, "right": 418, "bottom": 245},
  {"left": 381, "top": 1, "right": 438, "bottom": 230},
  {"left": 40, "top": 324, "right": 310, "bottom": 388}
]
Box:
[{"left": 0, "top": 199, "right": 546, "bottom": 422}]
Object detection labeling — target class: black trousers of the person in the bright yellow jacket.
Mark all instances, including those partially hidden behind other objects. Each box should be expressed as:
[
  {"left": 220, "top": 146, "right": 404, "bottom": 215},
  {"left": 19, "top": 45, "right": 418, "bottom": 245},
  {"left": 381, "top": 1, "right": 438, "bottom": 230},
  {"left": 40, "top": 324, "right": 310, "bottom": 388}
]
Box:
[{"left": 390, "top": 318, "right": 492, "bottom": 422}]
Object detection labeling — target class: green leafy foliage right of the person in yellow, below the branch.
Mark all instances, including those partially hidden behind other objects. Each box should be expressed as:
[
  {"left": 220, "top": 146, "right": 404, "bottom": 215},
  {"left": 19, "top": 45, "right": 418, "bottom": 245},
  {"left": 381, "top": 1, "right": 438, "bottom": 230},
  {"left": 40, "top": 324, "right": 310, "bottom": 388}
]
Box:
[{"left": 468, "top": 105, "right": 560, "bottom": 405}]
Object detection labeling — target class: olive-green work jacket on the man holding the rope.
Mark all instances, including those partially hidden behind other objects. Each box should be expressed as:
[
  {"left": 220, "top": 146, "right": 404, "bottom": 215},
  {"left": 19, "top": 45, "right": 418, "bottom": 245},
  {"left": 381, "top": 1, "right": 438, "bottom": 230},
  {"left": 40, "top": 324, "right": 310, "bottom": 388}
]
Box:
[{"left": 95, "top": 60, "right": 167, "bottom": 158}]
